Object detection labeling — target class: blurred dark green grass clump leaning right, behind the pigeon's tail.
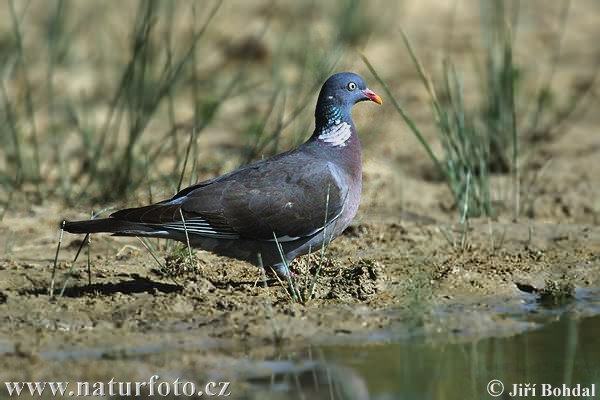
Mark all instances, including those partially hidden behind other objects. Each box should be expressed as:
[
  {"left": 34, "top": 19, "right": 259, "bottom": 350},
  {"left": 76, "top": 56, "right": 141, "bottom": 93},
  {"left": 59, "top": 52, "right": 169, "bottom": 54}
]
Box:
[{"left": 77, "top": 1, "right": 219, "bottom": 200}]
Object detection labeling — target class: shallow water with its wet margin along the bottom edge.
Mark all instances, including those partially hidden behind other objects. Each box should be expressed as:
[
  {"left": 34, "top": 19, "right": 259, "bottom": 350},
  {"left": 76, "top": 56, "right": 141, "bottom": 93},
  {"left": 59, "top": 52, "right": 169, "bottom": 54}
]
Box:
[{"left": 0, "top": 289, "right": 600, "bottom": 400}]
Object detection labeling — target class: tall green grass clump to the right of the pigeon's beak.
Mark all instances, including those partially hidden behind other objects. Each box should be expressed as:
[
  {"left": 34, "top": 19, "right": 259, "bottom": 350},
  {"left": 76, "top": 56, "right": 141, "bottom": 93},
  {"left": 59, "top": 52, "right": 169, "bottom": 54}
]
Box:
[{"left": 363, "top": 0, "right": 597, "bottom": 221}]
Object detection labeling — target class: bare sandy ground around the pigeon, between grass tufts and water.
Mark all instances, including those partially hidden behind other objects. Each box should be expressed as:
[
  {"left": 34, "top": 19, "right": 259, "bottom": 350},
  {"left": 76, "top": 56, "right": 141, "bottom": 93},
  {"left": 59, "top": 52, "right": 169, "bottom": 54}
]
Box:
[{"left": 0, "top": 1, "right": 600, "bottom": 394}]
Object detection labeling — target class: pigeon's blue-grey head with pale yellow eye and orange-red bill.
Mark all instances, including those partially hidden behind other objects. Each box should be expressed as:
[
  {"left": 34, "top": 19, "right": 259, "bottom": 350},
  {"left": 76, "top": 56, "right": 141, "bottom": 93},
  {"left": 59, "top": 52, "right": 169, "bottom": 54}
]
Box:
[{"left": 315, "top": 72, "right": 381, "bottom": 125}]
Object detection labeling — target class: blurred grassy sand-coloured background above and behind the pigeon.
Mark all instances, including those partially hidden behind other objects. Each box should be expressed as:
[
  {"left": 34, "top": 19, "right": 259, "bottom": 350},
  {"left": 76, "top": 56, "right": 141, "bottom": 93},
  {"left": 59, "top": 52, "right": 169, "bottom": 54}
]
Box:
[{"left": 0, "top": 0, "right": 600, "bottom": 221}]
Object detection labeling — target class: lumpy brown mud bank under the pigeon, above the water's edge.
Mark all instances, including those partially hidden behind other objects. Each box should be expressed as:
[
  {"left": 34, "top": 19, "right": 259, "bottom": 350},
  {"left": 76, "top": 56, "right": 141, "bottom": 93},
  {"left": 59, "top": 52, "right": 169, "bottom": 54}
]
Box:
[{"left": 0, "top": 215, "right": 600, "bottom": 379}]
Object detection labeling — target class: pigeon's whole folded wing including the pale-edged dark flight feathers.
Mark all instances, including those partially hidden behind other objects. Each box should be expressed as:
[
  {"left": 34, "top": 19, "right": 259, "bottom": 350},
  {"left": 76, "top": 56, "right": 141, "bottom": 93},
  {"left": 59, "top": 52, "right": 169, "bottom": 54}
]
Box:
[{"left": 111, "top": 156, "right": 347, "bottom": 241}]
